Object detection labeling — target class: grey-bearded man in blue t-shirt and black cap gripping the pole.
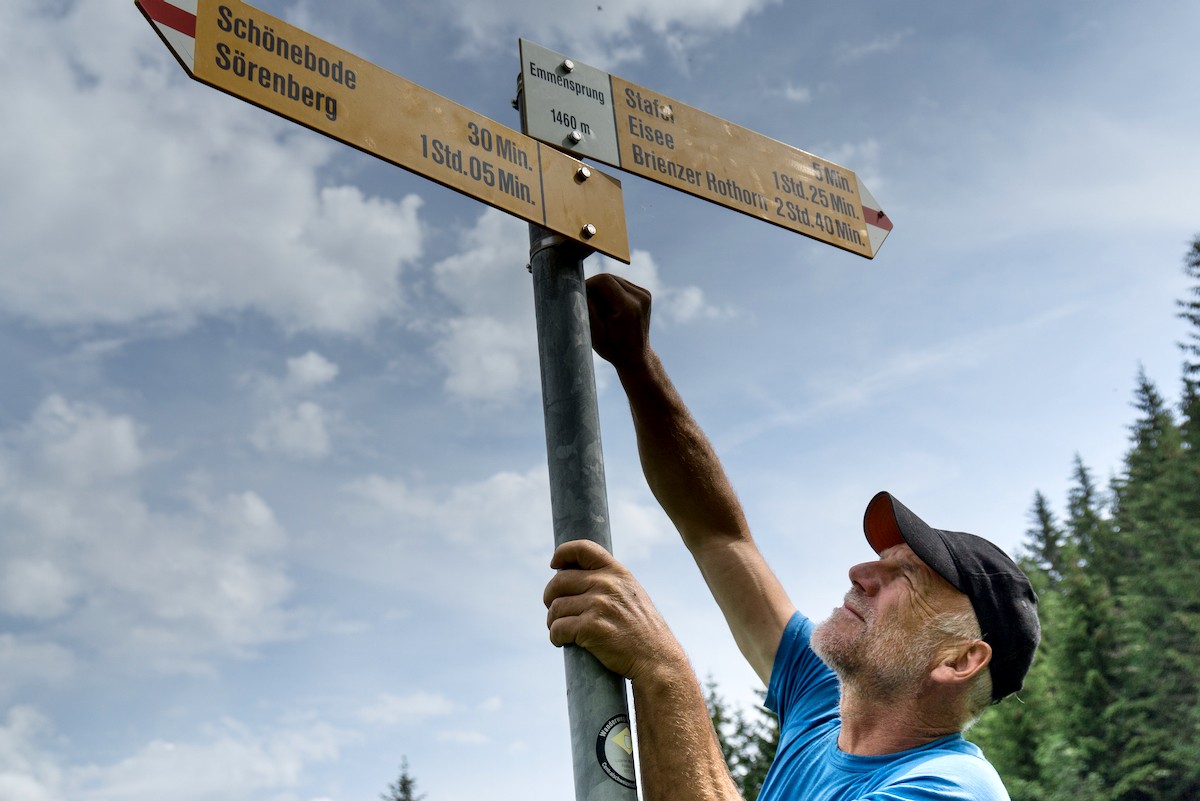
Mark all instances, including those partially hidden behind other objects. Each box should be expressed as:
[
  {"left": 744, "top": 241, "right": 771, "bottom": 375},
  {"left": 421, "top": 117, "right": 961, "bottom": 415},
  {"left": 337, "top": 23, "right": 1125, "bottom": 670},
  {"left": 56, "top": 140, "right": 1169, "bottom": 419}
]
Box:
[{"left": 545, "top": 275, "right": 1039, "bottom": 801}]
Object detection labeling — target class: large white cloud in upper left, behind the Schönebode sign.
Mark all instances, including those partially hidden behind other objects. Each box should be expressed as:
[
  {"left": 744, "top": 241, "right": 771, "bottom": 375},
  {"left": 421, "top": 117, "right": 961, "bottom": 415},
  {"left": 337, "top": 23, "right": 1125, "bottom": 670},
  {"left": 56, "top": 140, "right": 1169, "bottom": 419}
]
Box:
[{"left": 0, "top": 0, "right": 422, "bottom": 333}]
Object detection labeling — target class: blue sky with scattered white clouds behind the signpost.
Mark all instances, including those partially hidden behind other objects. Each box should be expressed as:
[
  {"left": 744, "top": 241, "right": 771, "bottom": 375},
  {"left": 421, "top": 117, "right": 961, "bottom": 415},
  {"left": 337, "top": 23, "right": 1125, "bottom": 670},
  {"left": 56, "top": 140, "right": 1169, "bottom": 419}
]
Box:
[{"left": 0, "top": 0, "right": 1200, "bottom": 801}]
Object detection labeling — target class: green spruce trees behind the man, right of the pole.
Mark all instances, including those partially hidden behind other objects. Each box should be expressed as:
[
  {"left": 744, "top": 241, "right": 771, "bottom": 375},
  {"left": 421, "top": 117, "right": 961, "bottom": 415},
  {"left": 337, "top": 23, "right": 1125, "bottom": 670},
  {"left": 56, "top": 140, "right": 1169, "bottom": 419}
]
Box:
[{"left": 708, "top": 235, "right": 1200, "bottom": 801}]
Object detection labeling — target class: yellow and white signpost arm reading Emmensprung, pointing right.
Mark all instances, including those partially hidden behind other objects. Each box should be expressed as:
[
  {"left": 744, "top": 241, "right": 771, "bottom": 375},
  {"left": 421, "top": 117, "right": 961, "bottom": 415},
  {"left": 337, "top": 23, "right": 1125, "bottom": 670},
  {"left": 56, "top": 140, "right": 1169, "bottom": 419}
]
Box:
[{"left": 521, "top": 40, "right": 892, "bottom": 258}]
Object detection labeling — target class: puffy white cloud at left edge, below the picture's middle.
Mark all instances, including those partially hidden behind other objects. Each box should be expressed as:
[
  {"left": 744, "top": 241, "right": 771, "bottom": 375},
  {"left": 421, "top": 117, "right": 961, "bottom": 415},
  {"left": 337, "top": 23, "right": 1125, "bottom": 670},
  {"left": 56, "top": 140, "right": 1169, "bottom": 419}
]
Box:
[{"left": 0, "top": 396, "right": 290, "bottom": 675}]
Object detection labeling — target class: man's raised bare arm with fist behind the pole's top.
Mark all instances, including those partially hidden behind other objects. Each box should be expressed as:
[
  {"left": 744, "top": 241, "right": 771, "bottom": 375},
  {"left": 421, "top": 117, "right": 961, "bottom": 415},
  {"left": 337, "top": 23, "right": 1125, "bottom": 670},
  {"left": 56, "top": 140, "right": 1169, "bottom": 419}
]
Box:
[{"left": 588, "top": 273, "right": 794, "bottom": 683}]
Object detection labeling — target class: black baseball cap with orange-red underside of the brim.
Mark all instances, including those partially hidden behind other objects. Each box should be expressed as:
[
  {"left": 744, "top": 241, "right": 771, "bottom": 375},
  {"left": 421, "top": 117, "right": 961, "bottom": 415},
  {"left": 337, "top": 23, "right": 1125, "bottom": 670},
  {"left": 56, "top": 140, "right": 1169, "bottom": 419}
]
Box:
[{"left": 863, "top": 493, "right": 1042, "bottom": 701}]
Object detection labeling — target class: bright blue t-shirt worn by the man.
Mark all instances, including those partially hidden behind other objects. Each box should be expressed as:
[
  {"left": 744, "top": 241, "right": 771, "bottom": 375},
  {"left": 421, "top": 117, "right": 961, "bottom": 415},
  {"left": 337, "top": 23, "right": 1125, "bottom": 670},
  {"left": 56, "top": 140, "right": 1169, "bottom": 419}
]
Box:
[{"left": 758, "top": 613, "right": 1008, "bottom": 801}]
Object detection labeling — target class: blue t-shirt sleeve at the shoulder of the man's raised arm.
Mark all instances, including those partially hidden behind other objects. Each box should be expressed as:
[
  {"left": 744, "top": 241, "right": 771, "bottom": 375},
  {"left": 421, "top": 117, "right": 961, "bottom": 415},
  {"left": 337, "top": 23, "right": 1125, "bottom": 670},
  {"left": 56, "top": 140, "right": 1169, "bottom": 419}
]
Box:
[{"left": 766, "top": 612, "right": 839, "bottom": 728}]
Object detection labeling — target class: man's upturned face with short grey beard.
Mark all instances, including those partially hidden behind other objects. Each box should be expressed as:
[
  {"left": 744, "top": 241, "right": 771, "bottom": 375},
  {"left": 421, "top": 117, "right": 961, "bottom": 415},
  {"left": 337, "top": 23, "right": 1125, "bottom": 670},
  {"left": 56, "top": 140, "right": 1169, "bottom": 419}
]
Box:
[{"left": 812, "top": 544, "right": 970, "bottom": 697}]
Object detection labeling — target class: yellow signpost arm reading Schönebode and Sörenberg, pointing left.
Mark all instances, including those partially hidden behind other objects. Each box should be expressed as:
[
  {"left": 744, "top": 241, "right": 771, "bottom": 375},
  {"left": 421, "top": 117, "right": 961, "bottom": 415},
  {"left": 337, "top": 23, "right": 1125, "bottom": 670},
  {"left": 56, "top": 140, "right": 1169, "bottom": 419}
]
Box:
[{"left": 136, "top": 0, "right": 629, "bottom": 263}]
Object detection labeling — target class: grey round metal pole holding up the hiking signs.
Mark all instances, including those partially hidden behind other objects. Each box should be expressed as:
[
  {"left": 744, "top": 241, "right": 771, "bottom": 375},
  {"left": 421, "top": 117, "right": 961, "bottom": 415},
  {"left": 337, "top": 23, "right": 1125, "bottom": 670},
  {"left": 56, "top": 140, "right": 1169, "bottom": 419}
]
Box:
[{"left": 529, "top": 225, "right": 637, "bottom": 801}]
